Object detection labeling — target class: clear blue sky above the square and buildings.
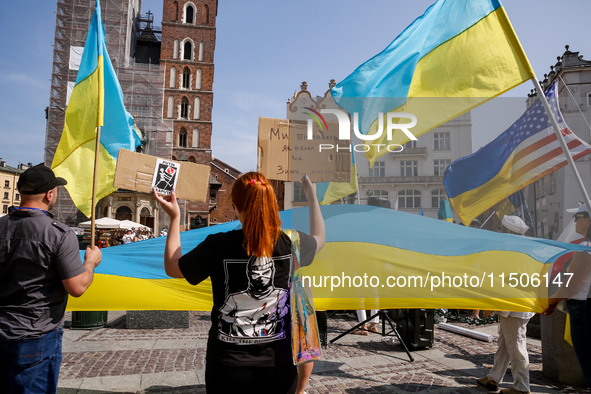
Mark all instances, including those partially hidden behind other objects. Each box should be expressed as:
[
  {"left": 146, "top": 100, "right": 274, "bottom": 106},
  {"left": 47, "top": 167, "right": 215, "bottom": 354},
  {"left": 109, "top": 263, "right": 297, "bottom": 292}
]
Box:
[{"left": 0, "top": 0, "right": 591, "bottom": 171}]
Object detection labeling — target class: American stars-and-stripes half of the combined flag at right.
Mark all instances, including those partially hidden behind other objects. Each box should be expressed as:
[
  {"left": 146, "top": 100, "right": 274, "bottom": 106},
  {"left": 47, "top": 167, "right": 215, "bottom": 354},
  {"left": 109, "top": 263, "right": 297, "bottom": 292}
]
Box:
[{"left": 505, "top": 82, "right": 591, "bottom": 184}]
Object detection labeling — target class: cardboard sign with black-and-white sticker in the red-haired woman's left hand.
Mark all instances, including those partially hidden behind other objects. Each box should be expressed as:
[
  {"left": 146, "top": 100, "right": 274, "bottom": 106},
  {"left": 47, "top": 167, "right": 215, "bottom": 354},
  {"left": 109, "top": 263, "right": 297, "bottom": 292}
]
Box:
[{"left": 113, "top": 149, "right": 210, "bottom": 202}]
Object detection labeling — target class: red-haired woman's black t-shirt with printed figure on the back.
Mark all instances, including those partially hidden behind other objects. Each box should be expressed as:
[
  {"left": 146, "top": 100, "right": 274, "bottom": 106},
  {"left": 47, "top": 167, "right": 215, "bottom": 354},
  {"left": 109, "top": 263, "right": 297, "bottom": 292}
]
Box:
[{"left": 179, "top": 230, "right": 316, "bottom": 367}]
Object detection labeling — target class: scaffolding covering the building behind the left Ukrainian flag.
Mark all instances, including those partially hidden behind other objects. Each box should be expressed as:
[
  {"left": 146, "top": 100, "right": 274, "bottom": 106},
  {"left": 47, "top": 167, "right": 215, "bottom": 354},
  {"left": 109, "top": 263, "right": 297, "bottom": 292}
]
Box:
[{"left": 44, "top": 0, "right": 178, "bottom": 226}]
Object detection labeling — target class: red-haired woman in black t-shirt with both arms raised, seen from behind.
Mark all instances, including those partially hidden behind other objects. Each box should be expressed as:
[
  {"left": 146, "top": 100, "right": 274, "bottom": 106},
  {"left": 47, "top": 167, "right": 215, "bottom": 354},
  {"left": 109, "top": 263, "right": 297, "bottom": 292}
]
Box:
[{"left": 154, "top": 172, "right": 324, "bottom": 394}]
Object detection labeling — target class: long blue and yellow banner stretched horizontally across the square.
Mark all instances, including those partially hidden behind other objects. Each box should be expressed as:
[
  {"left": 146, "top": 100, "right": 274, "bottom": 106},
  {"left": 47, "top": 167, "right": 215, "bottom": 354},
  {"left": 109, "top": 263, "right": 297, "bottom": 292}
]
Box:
[{"left": 68, "top": 205, "right": 591, "bottom": 312}]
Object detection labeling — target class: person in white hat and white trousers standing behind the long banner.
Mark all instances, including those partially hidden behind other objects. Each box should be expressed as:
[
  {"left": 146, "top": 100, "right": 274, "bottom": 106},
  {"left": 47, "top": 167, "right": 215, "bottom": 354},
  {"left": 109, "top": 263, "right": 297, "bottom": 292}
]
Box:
[{"left": 478, "top": 215, "right": 535, "bottom": 394}]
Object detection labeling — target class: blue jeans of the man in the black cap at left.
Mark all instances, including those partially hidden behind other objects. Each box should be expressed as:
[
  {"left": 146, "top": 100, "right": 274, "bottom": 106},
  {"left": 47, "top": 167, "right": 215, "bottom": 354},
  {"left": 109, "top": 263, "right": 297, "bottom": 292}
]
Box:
[{"left": 0, "top": 328, "right": 64, "bottom": 394}]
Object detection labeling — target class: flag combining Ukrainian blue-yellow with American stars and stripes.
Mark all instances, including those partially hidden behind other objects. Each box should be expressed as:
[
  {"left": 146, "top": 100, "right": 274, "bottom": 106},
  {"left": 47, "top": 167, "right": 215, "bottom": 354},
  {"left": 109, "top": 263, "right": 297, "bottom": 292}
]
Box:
[{"left": 443, "top": 82, "right": 591, "bottom": 225}]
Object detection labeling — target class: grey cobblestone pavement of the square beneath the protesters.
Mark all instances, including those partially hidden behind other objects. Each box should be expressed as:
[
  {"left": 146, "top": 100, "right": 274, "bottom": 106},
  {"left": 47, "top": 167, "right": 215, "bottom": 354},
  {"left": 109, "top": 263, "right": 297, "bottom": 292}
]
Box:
[{"left": 58, "top": 312, "right": 589, "bottom": 394}]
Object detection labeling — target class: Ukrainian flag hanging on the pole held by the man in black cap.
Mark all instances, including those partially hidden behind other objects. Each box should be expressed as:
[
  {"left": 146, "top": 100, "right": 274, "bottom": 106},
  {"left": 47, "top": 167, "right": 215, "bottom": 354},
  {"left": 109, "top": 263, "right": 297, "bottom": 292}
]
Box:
[{"left": 51, "top": 1, "right": 140, "bottom": 217}]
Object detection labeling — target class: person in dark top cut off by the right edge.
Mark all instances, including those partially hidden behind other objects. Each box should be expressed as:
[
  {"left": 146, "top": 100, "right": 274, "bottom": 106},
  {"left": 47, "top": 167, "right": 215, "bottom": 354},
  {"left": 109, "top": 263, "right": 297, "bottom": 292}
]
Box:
[{"left": 544, "top": 204, "right": 591, "bottom": 387}]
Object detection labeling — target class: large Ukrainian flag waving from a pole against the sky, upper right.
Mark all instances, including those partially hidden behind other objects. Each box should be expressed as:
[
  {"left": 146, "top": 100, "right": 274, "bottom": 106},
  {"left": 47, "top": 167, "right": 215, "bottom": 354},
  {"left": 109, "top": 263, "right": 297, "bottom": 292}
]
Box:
[{"left": 331, "top": 0, "right": 534, "bottom": 166}]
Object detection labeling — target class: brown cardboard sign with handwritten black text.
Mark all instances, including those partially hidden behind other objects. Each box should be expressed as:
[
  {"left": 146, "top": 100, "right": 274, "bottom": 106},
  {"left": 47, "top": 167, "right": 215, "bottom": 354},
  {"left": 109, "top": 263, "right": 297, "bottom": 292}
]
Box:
[{"left": 257, "top": 117, "right": 351, "bottom": 182}]
